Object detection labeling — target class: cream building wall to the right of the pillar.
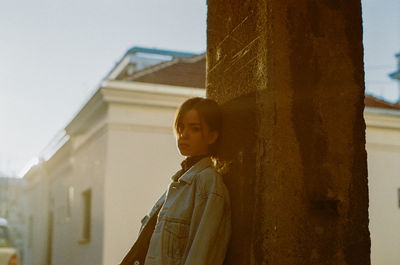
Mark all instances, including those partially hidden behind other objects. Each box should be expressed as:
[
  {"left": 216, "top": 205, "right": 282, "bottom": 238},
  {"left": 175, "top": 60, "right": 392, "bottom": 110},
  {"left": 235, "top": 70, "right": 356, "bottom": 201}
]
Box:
[{"left": 365, "top": 108, "right": 400, "bottom": 265}]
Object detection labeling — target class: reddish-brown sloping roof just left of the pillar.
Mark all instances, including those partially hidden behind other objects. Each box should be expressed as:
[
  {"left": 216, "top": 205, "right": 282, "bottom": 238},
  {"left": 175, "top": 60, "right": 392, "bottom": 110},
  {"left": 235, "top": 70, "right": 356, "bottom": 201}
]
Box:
[{"left": 121, "top": 54, "right": 206, "bottom": 88}]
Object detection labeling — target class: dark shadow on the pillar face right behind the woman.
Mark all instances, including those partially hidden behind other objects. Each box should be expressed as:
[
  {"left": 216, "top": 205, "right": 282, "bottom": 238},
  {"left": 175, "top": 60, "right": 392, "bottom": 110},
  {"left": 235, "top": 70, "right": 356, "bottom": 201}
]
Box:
[{"left": 214, "top": 93, "right": 257, "bottom": 264}]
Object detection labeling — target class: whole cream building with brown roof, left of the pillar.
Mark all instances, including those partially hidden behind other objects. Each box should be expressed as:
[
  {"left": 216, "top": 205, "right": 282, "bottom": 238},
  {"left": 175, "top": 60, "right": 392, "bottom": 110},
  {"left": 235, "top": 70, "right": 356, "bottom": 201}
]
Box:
[{"left": 24, "top": 49, "right": 205, "bottom": 265}]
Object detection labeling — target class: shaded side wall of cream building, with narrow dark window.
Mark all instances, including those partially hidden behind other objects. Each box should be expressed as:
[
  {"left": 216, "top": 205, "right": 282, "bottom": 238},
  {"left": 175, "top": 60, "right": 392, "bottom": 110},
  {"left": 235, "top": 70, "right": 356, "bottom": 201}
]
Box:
[{"left": 38, "top": 110, "right": 107, "bottom": 265}]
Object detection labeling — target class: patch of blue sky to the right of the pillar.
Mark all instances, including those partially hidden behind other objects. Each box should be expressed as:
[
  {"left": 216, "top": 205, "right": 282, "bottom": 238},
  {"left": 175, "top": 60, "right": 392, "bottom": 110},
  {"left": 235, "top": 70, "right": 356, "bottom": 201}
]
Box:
[{"left": 362, "top": 0, "right": 400, "bottom": 101}]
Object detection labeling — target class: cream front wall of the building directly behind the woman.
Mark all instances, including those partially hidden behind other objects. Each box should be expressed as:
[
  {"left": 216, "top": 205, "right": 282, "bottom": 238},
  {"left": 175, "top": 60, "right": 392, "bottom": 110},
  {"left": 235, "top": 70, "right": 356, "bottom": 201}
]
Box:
[{"left": 102, "top": 102, "right": 183, "bottom": 265}]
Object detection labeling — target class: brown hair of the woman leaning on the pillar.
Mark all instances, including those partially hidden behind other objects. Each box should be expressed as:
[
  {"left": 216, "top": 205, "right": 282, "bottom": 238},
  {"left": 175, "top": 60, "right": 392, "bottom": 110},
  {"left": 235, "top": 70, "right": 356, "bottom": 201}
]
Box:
[{"left": 174, "top": 97, "right": 222, "bottom": 156}]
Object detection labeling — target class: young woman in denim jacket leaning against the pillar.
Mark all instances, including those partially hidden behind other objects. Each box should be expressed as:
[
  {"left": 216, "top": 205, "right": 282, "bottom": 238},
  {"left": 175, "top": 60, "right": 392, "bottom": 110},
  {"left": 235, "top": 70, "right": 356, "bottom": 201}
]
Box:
[{"left": 121, "top": 98, "right": 231, "bottom": 265}]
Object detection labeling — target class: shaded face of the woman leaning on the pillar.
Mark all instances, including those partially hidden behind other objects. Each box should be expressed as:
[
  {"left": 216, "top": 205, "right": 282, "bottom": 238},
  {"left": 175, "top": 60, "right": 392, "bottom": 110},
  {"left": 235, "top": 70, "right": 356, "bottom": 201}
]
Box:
[{"left": 176, "top": 109, "right": 218, "bottom": 157}]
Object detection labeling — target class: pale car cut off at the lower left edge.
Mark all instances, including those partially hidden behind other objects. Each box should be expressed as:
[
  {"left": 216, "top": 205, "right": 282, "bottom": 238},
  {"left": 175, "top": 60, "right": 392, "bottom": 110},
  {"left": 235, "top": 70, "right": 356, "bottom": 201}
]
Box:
[{"left": 0, "top": 217, "right": 19, "bottom": 265}]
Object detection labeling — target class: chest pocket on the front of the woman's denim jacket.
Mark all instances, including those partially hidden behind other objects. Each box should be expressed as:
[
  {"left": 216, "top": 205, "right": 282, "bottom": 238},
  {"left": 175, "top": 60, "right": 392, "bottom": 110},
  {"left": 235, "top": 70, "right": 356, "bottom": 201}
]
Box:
[{"left": 163, "top": 221, "right": 189, "bottom": 259}]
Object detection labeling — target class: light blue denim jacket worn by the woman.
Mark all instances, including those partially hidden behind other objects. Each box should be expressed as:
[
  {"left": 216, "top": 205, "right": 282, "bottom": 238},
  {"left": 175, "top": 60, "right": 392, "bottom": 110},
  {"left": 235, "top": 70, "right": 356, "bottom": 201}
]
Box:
[{"left": 142, "top": 157, "right": 231, "bottom": 265}]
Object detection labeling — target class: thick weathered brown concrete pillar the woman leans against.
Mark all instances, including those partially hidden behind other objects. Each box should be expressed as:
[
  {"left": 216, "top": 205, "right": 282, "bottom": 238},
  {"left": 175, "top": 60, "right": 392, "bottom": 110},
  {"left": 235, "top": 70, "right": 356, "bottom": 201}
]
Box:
[{"left": 207, "top": 0, "right": 370, "bottom": 265}]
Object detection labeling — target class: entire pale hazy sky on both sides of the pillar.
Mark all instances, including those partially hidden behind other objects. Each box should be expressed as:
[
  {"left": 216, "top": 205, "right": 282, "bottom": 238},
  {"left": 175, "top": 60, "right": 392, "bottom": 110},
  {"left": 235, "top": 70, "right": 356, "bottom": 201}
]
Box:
[{"left": 0, "top": 0, "right": 400, "bottom": 176}]
